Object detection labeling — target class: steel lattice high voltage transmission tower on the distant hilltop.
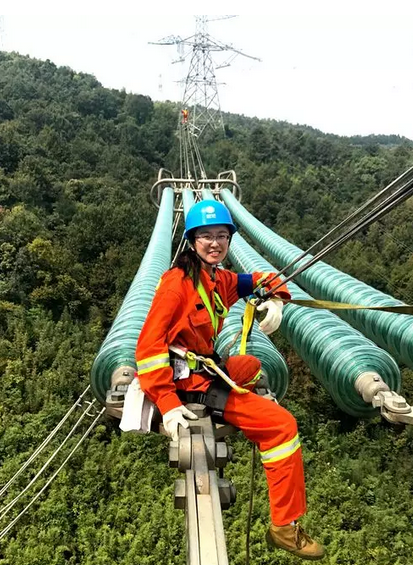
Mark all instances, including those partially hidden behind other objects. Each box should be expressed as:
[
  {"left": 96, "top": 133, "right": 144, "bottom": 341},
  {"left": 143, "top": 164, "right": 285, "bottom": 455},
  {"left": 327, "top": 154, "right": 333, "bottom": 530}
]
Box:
[{"left": 151, "top": 16, "right": 260, "bottom": 137}]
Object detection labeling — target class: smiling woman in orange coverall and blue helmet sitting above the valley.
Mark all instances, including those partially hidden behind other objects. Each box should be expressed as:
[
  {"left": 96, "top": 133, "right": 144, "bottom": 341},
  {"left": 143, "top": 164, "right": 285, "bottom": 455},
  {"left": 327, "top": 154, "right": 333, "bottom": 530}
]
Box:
[{"left": 136, "top": 200, "right": 324, "bottom": 560}]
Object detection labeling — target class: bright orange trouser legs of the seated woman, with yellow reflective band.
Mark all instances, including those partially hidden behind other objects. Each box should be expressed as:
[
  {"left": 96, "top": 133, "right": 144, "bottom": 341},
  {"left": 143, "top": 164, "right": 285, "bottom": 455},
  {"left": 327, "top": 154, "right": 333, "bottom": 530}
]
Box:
[{"left": 224, "top": 355, "right": 306, "bottom": 526}]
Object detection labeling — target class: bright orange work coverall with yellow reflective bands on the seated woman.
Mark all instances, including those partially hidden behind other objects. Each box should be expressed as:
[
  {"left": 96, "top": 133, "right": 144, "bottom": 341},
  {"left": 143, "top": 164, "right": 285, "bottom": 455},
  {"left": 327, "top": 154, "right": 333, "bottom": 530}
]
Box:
[{"left": 136, "top": 268, "right": 306, "bottom": 526}]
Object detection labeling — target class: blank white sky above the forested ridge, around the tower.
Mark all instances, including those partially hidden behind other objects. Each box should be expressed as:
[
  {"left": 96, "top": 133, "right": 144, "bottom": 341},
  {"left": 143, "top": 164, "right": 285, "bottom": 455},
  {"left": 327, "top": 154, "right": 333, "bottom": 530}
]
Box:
[{"left": 1, "top": 0, "right": 413, "bottom": 139}]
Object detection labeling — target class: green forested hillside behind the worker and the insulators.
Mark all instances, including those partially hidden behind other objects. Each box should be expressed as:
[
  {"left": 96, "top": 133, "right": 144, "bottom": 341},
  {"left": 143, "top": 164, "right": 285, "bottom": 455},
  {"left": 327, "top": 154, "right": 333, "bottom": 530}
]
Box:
[{"left": 0, "top": 52, "right": 413, "bottom": 565}]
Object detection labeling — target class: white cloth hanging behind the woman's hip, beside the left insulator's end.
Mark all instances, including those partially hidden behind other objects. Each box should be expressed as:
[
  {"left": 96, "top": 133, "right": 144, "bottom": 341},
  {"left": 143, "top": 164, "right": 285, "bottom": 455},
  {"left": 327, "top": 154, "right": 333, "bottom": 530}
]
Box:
[{"left": 119, "top": 377, "right": 155, "bottom": 434}]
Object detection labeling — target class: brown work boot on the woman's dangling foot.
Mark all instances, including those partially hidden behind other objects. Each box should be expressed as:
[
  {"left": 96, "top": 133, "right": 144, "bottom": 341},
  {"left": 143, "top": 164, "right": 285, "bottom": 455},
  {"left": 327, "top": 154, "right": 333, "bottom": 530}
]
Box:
[{"left": 266, "top": 524, "right": 325, "bottom": 561}]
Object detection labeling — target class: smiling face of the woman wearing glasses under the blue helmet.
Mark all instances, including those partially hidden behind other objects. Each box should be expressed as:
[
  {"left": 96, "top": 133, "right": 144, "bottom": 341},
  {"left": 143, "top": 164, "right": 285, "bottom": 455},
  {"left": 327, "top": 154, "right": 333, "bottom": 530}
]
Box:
[{"left": 193, "top": 225, "right": 231, "bottom": 272}]
